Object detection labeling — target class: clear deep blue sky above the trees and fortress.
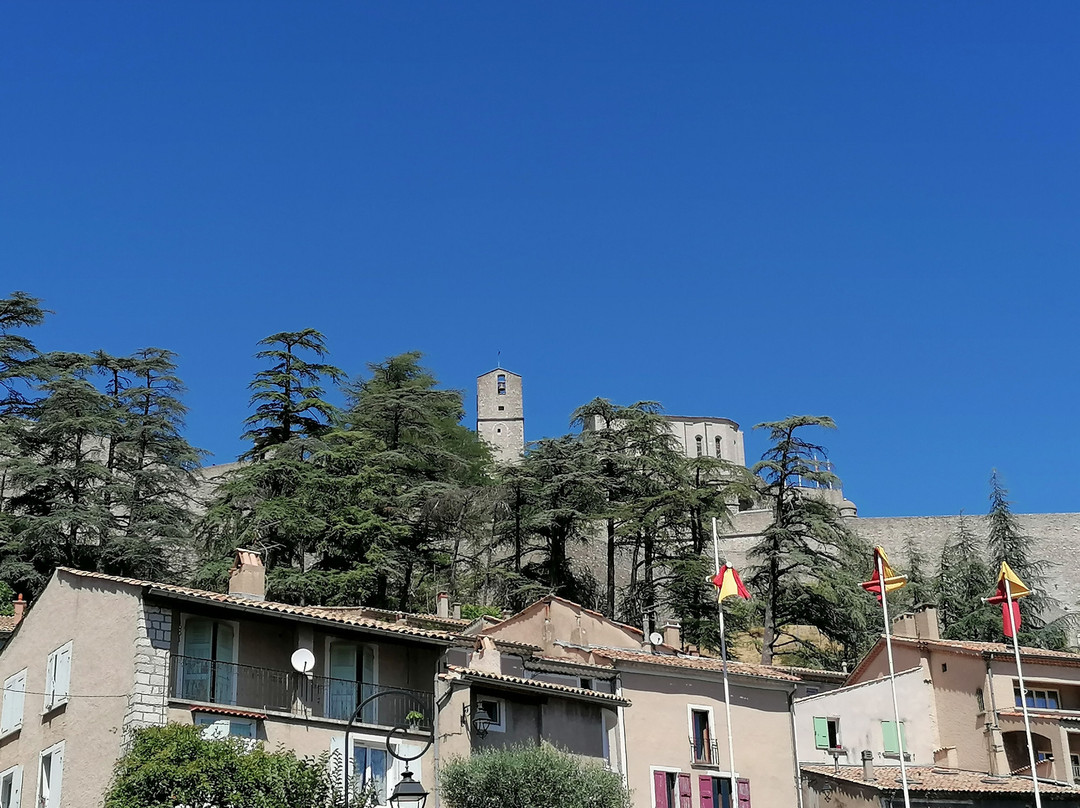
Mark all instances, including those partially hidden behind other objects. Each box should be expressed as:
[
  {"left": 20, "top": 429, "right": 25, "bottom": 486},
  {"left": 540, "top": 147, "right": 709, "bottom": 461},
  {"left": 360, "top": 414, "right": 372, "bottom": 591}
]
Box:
[{"left": 0, "top": 0, "right": 1080, "bottom": 515}]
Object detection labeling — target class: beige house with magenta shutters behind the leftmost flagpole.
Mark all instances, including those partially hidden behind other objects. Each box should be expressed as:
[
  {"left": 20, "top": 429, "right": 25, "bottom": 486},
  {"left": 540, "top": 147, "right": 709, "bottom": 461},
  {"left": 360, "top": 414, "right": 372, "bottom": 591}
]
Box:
[{"left": 477, "top": 596, "right": 828, "bottom": 808}]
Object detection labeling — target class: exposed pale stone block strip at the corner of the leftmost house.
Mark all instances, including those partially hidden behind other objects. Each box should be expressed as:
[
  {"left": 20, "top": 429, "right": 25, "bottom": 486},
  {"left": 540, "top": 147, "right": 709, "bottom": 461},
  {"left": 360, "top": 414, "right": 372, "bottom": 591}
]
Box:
[{"left": 123, "top": 603, "right": 173, "bottom": 738}]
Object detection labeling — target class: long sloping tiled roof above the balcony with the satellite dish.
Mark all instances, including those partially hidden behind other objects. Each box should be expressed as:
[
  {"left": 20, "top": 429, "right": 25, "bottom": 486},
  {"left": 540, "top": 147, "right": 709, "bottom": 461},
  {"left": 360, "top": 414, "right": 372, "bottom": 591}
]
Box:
[{"left": 56, "top": 567, "right": 458, "bottom": 645}]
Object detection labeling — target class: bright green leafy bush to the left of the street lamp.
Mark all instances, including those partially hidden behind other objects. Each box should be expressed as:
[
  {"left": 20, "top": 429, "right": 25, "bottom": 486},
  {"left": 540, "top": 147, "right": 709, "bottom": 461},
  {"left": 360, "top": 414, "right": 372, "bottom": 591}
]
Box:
[{"left": 104, "top": 724, "right": 343, "bottom": 808}]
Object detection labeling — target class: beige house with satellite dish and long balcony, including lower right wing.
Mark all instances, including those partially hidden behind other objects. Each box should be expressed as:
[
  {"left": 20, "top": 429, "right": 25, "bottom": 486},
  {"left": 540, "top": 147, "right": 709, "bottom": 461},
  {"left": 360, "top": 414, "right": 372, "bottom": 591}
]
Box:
[{"left": 0, "top": 551, "right": 629, "bottom": 808}]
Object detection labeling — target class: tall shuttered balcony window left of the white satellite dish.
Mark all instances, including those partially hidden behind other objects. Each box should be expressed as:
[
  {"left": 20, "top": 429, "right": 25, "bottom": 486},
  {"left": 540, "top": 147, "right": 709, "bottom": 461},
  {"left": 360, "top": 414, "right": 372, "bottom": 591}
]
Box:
[{"left": 180, "top": 617, "right": 237, "bottom": 704}]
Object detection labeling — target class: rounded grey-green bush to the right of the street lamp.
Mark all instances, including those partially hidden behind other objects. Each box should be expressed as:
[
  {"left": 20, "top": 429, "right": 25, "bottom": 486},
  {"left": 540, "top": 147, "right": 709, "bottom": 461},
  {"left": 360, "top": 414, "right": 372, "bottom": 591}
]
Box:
[{"left": 440, "top": 744, "right": 631, "bottom": 808}]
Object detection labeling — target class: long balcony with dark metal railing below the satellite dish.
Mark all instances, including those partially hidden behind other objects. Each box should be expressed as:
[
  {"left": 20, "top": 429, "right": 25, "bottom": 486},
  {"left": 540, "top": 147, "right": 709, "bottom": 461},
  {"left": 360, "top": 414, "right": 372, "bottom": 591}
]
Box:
[{"left": 168, "top": 656, "right": 435, "bottom": 728}]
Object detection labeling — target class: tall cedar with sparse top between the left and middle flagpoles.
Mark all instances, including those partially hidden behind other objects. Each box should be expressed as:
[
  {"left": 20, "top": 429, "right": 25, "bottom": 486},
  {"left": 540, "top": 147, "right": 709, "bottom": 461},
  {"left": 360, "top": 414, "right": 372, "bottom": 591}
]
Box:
[{"left": 746, "top": 416, "right": 869, "bottom": 664}]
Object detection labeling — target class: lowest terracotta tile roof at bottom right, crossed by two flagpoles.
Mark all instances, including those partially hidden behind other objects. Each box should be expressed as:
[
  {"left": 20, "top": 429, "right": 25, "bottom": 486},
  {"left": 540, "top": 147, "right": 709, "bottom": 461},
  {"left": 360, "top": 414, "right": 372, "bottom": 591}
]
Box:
[{"left": 801, "top": 765, "right": 1080, "bottom": 794}]
